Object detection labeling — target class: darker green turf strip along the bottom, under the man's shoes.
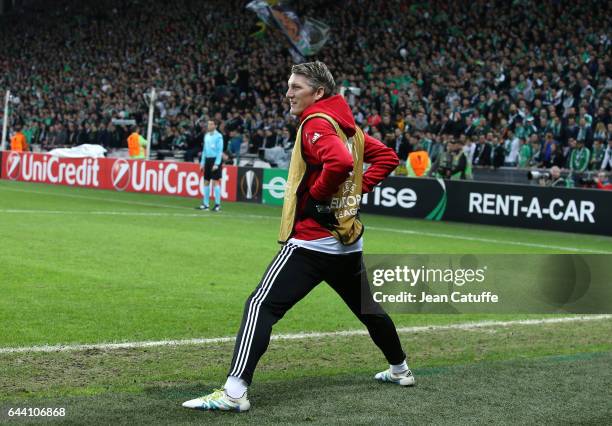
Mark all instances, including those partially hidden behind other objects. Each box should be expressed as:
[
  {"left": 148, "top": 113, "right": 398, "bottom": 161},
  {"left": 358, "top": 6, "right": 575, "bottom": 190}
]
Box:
[{"left": 0, "top": 352, "right": 612, "bottom": 425}]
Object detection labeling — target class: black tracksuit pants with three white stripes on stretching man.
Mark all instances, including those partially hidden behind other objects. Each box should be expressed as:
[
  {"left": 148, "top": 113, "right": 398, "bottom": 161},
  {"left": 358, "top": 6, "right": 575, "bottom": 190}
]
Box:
[{"left": 228, "top": 243, "right": 406, "bottom": 384}]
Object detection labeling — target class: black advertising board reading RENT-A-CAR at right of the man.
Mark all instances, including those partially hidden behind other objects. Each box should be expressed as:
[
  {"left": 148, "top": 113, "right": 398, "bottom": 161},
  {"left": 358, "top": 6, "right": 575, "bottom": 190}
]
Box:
[{"left": 361, "top": 177, "right": 612, "bottom": 235}]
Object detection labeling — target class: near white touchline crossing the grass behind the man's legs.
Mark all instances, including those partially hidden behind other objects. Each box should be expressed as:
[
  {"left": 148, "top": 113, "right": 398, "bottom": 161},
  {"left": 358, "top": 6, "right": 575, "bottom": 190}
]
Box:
[{"left": 0, "top": 314, "right": 612, "bottom": 354}]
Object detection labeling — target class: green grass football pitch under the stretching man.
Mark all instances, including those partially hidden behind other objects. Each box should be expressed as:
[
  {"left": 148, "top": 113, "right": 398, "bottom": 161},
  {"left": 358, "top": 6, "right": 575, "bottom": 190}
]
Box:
[{"left": 0, "top": 181, "right": 612, "bottom": 424}]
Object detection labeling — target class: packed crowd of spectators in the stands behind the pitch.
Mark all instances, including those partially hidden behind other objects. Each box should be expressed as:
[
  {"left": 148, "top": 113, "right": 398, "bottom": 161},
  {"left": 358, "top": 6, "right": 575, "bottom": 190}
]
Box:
[{"left": 0, "top": 0, "right": 612, "bottom": 176}]
